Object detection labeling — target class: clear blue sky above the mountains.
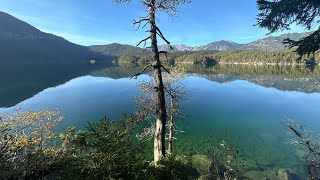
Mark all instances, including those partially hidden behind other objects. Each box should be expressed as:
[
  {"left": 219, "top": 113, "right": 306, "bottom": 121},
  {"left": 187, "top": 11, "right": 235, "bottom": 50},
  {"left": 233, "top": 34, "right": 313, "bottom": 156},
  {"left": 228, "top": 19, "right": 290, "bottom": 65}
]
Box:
[{"left": 0, "top": 0, "right": 314, "bottom": 46}]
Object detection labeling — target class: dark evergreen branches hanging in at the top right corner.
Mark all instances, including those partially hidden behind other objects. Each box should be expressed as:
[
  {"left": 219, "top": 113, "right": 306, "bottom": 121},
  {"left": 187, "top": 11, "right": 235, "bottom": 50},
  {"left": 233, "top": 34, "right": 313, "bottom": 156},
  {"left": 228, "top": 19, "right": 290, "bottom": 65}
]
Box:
[{"left": 257, "top": 0, "right": 320, "bottom": 57}]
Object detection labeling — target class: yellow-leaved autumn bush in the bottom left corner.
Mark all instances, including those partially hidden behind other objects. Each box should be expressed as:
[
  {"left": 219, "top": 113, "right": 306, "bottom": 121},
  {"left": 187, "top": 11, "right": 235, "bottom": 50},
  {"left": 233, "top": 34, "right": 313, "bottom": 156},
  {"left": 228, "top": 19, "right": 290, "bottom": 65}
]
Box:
[{"left": 0, "top": 109, "right": 64, "bottom": 179}]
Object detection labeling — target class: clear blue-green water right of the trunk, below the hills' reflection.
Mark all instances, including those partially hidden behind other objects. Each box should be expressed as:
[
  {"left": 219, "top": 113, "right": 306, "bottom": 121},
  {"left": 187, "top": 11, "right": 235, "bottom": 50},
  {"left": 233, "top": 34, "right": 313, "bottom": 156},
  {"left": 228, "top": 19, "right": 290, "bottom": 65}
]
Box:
[{"left": 177, "top": 77, "right": 320, "bottom": 179}]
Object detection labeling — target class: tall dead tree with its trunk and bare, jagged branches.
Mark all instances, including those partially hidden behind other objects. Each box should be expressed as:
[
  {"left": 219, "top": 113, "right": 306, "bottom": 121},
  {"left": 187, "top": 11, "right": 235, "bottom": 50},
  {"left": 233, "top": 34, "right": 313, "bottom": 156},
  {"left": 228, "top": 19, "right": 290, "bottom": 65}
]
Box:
[{"left": 114, "top": 0, "right": 189, "bottom": 163}]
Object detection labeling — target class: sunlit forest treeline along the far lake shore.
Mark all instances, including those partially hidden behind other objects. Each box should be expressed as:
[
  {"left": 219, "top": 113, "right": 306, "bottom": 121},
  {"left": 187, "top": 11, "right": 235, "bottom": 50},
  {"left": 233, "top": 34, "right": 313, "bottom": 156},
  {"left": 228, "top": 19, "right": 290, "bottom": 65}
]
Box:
[{"left": 118, "top": 49, "right": 320, "bottom": 65}]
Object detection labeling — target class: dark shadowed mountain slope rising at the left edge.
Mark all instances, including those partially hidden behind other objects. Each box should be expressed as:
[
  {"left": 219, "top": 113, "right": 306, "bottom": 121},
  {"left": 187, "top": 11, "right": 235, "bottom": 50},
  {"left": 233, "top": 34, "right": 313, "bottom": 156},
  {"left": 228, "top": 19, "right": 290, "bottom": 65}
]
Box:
[{"left": 0, "top": 11, "right": 92, "bottom": 63}]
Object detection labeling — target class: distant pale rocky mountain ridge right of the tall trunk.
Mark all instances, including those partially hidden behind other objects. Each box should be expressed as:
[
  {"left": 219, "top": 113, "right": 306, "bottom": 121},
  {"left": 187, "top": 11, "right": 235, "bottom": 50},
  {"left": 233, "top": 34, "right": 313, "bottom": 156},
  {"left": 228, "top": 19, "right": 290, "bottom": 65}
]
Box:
[{"left": 159, "top": 32, "right": 310, "bottom": 51}]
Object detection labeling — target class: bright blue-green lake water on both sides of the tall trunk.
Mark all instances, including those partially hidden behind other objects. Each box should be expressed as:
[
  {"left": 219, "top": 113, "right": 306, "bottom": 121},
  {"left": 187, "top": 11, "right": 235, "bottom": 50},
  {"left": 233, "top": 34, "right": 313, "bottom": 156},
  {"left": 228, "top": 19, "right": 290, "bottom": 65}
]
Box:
[{"left": 0, "top": 63, "right": 320, "bottom": 179}]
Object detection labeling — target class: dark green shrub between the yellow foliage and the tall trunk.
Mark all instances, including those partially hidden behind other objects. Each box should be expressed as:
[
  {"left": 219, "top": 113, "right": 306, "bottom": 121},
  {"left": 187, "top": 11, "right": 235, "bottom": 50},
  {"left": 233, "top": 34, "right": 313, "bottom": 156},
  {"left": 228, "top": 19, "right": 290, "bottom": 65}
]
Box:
[{"left": 65, "top": 117, "right": 147, "bottom": 179}]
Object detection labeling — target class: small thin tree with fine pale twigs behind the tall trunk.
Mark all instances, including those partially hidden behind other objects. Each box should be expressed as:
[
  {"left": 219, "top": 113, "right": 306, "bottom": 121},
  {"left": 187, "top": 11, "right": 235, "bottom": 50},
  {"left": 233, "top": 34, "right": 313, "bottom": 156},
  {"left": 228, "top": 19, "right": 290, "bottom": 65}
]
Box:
[{"left": 136, "top": 67, "right": 187, "bottom": 157}]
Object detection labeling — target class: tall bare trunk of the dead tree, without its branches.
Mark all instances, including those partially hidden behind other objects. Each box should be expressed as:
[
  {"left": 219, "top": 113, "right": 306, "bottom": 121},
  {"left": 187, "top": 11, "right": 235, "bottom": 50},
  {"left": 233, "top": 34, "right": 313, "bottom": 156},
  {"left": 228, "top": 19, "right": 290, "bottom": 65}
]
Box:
[{"left": 149, "top": 0, "right": 167, "bottom": 164}]
